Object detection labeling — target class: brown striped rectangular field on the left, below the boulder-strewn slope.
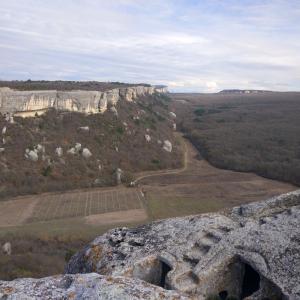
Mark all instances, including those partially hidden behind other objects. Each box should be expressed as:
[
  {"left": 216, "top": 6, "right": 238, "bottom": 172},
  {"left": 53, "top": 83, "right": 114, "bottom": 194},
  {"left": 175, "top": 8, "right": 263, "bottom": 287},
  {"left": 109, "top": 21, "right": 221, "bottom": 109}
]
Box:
[{"left": 0, "top": 188, "right": 144, "bottom": 227}]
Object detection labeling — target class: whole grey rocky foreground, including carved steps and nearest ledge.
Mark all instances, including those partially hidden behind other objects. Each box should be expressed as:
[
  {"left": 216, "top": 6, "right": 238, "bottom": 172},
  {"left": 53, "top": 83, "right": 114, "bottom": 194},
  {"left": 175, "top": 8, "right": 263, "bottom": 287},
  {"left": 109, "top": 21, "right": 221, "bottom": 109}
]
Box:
[{"left": 0, "top": 190, "right": 300, "bottom": 300}]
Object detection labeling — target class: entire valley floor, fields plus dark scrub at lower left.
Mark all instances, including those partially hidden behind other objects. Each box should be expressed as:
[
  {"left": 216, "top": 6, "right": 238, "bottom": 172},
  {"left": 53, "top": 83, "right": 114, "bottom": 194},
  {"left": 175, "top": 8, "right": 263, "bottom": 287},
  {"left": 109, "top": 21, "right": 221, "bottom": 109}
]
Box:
[{"left": 0, "top": 134, "right": 297, "bottom": 279}]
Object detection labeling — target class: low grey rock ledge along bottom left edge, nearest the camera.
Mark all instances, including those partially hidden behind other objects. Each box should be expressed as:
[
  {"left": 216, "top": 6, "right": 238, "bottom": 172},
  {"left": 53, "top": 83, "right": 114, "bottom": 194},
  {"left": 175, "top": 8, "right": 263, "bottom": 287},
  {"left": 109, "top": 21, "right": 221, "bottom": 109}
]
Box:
[{"left": 0, "top": 273, "right": 188, "bottom": 300}]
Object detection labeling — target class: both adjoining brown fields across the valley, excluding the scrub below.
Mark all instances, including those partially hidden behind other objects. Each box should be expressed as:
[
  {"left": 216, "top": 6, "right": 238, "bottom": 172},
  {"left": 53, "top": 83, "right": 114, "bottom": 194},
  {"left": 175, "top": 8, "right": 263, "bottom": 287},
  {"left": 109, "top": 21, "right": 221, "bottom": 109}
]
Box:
[{"left": 0, "top": 134, "right": 296, "bottom": 228}]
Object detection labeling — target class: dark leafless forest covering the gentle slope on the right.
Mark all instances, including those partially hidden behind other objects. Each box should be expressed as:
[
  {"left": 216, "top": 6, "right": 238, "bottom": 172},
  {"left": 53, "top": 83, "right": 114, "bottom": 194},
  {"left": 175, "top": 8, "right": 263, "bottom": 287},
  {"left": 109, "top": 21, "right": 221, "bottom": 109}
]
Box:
[{"left": 172, "top": 92, "right": 300, "bottom": 186}]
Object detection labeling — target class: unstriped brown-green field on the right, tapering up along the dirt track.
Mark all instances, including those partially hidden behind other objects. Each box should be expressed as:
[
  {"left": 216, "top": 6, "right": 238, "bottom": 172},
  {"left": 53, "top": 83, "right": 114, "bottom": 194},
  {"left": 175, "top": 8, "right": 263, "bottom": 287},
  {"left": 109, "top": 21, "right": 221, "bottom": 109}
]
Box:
[{"left": 139, "top": 134, "right": 298, "bottom": 219}]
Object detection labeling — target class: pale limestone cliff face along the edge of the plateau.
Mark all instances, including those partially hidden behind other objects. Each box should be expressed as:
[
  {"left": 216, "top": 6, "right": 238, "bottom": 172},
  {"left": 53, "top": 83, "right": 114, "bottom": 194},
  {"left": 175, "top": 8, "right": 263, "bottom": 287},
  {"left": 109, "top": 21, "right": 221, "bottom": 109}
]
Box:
[{"left": 0, "top": 86, "right": 167, "bottom": 117}]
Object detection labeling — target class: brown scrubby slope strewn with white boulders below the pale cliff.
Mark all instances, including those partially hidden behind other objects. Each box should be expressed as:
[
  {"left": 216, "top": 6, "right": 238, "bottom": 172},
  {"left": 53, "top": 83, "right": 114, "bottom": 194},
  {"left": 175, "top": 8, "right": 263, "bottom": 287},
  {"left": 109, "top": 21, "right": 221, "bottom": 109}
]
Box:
[{"left": 0, "top": 94, "right": 182, "bottom": 198}]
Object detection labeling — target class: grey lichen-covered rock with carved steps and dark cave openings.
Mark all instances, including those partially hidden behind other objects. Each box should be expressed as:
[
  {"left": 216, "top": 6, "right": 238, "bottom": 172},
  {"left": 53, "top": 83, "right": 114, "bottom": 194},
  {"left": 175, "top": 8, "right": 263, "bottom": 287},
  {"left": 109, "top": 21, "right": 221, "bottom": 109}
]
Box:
[{"left": 66, "top": 191, "right": 300, "bottom": 299}]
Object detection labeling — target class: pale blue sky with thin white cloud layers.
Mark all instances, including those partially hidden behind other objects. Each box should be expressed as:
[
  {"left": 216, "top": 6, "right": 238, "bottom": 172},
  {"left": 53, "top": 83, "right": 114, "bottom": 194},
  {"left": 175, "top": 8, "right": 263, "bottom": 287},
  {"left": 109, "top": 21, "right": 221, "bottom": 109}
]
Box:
[{"left": 0, "top": 0, "right": 300, "bottom": 92}]
